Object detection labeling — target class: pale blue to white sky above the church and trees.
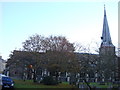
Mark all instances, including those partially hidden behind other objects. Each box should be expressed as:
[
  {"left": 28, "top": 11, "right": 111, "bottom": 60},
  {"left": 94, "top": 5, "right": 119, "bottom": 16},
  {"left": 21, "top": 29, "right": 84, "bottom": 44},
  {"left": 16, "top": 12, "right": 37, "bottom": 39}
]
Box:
[{"left": 0, "top": 0, "right": 118, "bottom": 59}]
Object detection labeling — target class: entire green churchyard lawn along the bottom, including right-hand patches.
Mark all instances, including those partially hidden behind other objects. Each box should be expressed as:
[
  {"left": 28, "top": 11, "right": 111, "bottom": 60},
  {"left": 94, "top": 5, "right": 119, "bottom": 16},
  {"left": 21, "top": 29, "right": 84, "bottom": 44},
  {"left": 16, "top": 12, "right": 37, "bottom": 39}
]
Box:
[{"left": 14, "top": 80, "right": 118, "bottom": 88}]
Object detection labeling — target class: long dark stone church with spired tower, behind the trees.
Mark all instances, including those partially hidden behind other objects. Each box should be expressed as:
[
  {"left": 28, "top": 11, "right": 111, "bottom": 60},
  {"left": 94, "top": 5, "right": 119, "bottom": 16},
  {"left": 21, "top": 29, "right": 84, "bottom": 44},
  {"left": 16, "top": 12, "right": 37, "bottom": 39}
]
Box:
[{"left": 4, "top": 6, "right": 120, "bottom": 82}]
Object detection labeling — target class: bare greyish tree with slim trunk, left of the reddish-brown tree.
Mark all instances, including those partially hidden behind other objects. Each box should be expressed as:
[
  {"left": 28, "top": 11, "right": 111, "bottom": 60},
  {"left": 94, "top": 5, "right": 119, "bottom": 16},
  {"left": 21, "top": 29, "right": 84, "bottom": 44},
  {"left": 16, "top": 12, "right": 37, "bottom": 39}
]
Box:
[{"left": 23, "top": 34, "right": 45, "bottom": 82}]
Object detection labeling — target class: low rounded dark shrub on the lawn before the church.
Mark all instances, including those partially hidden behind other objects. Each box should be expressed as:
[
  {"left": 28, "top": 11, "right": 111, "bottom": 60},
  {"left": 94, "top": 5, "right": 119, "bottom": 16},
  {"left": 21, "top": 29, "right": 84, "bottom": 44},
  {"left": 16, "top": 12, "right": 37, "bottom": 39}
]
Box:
[{"left": 41, "top": 76, "right": 58, "bottom": 85}]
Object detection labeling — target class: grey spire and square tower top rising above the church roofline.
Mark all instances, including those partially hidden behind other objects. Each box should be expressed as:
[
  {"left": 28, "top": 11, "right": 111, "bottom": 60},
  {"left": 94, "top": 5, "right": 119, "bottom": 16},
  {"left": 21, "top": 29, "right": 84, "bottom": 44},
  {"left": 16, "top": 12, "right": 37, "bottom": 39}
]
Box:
[{"left": 99, "top": 6, "right": 115, "bottom": 55}]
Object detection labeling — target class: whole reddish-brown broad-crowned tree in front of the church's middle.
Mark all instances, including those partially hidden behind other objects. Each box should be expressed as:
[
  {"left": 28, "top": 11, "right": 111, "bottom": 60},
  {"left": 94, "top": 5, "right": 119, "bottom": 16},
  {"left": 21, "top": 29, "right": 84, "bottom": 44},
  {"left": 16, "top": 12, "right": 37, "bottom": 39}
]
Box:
[{"left": 44, "top": 36, "right": 75, "bottom": 80}]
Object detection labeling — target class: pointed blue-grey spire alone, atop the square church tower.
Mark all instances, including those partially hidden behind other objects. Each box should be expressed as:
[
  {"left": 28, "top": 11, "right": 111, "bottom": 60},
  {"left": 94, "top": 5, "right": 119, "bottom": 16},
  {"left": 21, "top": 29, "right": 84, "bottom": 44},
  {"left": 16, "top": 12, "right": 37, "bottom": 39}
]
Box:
[{"left": 101, "top": 5, "right": 113, "bottom": 46}]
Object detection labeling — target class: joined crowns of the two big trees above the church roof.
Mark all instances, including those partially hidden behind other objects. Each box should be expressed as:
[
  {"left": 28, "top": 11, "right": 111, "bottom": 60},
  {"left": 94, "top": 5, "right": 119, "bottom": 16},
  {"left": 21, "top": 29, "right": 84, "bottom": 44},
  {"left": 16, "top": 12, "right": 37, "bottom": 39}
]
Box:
[{"left": 23, "top": 34, "right": 75, "bottom": 52}]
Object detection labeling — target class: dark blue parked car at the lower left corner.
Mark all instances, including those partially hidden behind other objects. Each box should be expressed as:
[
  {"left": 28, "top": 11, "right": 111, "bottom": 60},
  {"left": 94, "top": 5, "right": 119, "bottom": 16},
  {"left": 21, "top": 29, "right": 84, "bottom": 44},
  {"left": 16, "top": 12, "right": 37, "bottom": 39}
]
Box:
[{"left": 0, "top": 74, "right": 14, "bottom": 89}]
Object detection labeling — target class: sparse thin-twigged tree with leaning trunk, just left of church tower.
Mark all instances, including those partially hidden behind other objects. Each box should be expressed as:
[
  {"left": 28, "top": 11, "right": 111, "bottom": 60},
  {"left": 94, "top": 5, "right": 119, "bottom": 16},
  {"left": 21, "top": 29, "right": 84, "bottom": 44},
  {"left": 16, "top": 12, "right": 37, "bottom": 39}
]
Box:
[{"left": 75, "top": 43, "right": 98, "bottom": 89}]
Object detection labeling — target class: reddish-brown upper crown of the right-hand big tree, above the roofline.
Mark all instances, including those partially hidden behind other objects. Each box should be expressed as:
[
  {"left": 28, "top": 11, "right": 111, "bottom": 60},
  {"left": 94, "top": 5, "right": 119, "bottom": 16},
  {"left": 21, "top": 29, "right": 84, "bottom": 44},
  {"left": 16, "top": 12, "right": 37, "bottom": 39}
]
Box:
[{"left": 44, "top": 35, "right": 74, "bottom": 52}]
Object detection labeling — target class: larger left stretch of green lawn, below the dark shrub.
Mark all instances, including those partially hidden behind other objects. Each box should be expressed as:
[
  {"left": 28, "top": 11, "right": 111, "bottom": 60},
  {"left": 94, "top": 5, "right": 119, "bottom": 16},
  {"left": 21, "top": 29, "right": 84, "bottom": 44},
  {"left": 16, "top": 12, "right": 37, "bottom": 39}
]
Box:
[{"left": 14, "top": 80, "right": 75, "bottom": 88}]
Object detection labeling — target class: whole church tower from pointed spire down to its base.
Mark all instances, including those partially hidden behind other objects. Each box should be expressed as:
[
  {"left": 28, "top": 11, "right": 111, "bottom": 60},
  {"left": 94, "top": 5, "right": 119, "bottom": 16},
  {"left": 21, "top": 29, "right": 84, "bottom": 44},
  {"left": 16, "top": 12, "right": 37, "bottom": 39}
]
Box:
[{"left": 99, "top": 6, "right": 116, "bottom": 81}]
